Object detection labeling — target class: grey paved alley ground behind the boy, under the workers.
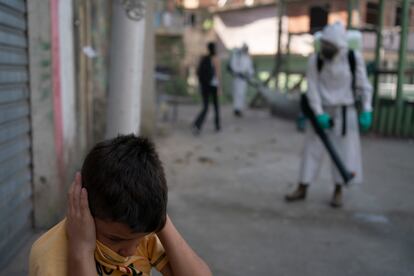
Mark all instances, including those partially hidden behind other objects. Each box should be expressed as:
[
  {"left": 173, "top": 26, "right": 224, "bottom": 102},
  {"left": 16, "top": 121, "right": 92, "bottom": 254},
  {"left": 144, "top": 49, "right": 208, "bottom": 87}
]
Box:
[{"left": 4, "top": 106, "right": 414, "bottom": 276}]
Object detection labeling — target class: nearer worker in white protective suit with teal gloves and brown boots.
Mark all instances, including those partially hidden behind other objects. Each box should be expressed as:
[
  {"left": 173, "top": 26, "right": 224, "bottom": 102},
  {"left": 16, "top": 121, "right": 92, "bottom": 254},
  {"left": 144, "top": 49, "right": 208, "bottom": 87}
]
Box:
[{"left": 286, "top": 23, "right": 372, "bottom": 207}]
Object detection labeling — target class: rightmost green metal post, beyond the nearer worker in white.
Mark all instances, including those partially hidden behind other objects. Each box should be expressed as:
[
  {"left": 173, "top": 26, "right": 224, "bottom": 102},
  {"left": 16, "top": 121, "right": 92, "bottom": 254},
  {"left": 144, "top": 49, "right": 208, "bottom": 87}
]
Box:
[{"left": 394, "top": 0, "right": 410, "bottom": 135}]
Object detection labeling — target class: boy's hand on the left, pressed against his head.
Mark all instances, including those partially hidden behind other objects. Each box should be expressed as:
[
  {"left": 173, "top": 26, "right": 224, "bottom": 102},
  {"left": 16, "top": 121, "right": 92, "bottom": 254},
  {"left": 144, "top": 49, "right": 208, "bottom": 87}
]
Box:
[{"left": 66, "top": 172, "right": 96, "bottom": 258}]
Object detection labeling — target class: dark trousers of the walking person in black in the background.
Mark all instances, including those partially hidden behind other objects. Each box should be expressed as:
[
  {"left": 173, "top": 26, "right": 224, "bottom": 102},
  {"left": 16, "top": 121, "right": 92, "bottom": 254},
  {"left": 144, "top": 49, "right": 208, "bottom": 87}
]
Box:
[{"left": 194, "top": 85, "right": 220, "bottom": 130}]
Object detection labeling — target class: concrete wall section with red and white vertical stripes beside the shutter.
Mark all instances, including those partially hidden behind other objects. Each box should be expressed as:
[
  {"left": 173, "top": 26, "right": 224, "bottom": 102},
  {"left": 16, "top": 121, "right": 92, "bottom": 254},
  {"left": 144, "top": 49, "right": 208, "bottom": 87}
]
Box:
[{"left": 28, "top": 0, "right": 84, "bottom": 228}]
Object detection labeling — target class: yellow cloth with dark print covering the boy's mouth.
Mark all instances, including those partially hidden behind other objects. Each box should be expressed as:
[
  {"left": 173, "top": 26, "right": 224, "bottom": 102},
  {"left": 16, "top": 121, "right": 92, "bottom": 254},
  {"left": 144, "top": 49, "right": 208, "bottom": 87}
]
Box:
[{"left": 95, "top": 241, "right": 141, "bottom": 275}]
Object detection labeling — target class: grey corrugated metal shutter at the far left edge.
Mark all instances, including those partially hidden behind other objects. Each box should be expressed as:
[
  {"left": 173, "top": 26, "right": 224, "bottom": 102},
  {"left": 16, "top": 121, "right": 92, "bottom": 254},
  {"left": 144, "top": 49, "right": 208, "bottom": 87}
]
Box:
[{"left": 0, "top": 0, "right": 33, "bottom": 265}]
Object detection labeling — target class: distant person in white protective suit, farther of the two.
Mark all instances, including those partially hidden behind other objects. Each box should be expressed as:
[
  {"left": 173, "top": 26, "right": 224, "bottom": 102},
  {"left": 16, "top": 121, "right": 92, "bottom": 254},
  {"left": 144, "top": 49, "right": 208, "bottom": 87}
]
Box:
[{"left": 230, "top": 44, "right": 254, "bottom": 117}]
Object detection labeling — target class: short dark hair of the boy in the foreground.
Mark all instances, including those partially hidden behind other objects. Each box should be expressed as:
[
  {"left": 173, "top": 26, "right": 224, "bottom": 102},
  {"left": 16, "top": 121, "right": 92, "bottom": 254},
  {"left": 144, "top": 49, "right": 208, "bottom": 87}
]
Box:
[{"left": 82, "top": 134, "right": 167, "bottom": 233}]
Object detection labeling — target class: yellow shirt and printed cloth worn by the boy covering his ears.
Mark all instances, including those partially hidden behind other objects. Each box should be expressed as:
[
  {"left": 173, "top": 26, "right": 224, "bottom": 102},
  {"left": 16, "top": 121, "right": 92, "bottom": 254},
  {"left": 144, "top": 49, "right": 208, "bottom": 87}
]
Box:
[{"left": 29, "top": 219, "right": 168, "bottom": 276}]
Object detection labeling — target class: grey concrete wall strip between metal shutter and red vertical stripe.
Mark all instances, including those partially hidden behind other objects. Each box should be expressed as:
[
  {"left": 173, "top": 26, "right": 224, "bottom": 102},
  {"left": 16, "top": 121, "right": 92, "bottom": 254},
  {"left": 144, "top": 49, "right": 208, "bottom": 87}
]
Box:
[{"left": 28, "top": 0, "right": 63, "bottom": 227}]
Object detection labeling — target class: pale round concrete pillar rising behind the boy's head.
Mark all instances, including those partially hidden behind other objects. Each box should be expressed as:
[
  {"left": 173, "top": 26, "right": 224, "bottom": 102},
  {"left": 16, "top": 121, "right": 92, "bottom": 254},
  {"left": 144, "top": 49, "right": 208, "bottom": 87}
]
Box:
[{"left": 105, "top": 0, "right": 147, "bottom": 138}]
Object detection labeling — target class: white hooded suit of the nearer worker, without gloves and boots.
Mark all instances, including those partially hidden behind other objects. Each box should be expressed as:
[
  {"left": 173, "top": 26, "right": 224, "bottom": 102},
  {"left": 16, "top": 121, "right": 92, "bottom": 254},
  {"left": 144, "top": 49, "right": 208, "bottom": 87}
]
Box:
[{"left": 300, "top": 24, "right": 372, "bottom": 184}]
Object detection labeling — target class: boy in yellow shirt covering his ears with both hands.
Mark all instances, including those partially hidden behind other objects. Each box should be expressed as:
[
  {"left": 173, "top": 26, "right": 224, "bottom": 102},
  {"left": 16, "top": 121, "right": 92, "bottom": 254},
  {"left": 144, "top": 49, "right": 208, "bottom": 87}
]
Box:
[{"left": 30, "top": 135, "right": 211, "bottom": 276}]
